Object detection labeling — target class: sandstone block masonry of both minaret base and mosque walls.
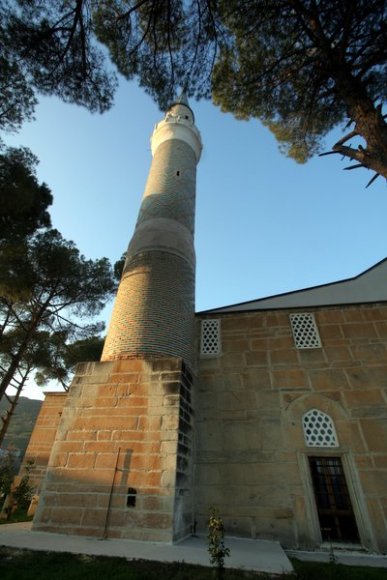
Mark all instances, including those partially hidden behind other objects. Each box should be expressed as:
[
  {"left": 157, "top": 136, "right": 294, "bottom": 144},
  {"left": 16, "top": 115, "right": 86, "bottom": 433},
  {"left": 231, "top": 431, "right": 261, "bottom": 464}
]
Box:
[{"left": 21, "top": 303, "right": 387, "bottom": 553}]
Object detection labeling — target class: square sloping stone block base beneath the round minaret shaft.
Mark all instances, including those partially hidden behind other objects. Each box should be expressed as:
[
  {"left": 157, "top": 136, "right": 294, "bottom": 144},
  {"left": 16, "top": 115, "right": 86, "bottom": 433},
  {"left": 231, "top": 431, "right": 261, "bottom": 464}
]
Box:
[{"left": 33, "top": 357, "right": 192, "bottom": 542}]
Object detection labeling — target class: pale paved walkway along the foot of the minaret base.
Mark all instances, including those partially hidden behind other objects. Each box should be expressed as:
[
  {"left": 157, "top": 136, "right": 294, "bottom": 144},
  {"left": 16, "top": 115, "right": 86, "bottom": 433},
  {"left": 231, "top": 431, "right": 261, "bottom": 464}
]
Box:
[{"left": 0, "top": 522, "right": 293, "bottom": 574}]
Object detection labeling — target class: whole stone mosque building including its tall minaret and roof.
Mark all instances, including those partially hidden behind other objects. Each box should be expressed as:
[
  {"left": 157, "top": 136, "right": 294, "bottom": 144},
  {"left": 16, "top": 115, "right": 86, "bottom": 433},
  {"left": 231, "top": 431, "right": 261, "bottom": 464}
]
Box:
[{"left": 22, "top": 94, "right": 387, "bottom": 553}]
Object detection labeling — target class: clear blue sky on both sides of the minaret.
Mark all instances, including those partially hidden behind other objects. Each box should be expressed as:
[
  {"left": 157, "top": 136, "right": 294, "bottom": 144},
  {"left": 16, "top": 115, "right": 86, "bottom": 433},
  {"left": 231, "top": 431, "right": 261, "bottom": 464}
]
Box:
[{"left": 6, "top": 81, "right": 387, "bottom": 396}]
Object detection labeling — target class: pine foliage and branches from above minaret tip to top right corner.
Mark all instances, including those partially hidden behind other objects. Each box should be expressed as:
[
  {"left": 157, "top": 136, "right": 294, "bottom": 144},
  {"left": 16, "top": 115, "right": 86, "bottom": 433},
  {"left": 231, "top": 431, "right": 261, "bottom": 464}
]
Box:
[{"left": 95, "top": 0, "right": 387, "bottom": 177}]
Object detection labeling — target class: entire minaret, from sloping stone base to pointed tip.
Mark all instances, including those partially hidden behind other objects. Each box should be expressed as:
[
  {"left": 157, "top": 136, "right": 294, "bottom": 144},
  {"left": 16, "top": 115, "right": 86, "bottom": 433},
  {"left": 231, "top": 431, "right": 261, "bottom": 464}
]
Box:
[{"left": 34, "top": 95, "right": 202, "bottom": 542}]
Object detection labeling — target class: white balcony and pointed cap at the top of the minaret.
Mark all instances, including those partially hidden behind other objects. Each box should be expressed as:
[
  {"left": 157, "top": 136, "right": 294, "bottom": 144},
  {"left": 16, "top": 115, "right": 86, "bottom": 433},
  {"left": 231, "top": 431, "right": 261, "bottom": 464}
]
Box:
[{"left": 151, "top": 91, "right": 202, "bottom": 162}]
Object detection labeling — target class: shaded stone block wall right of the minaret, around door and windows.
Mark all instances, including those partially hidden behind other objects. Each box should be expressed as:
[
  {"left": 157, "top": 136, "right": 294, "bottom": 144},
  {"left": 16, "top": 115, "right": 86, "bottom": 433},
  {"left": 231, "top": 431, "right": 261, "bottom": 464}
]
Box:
[{"left": 195, "top": 303, "right": 387, "bottom": 552}]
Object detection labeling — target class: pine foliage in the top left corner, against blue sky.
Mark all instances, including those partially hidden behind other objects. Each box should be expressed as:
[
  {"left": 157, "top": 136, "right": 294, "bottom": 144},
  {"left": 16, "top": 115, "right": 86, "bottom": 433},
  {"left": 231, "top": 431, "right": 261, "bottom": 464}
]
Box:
[{"left": 0, "top": 0, "right": 116, "bottom": 130}]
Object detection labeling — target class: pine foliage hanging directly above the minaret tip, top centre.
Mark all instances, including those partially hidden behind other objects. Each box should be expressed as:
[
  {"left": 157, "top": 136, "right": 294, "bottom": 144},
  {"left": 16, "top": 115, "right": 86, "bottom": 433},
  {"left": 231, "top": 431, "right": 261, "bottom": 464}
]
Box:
[{"left": 93, "top": 0, "right": 218, "bottom": 110}]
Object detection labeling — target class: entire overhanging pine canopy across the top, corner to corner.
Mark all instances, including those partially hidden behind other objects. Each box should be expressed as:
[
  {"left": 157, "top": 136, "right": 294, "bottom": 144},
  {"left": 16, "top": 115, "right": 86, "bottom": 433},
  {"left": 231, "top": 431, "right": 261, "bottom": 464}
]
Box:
[{"left": 0, "top": 0, "right": 387, "bottom": 177}]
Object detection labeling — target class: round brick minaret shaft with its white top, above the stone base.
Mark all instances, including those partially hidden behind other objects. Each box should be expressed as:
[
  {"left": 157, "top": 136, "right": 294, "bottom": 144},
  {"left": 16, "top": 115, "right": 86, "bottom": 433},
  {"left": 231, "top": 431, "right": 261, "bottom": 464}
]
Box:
[{"left": 101, "top": 93, "right": 202, "bottom": 368}]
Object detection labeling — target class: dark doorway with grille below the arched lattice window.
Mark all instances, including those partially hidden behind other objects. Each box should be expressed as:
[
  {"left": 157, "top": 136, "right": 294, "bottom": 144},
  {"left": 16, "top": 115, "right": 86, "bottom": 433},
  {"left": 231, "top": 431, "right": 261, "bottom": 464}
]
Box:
[{"left": 309, "top": 457, "right": 360, "bottom": 544}]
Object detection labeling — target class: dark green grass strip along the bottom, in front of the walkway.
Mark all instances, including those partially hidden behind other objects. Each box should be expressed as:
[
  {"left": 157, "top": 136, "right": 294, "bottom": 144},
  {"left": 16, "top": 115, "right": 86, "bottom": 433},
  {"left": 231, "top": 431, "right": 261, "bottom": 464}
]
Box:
[{"left": 0, "top": 547, "right": 387, "bottom": 580}]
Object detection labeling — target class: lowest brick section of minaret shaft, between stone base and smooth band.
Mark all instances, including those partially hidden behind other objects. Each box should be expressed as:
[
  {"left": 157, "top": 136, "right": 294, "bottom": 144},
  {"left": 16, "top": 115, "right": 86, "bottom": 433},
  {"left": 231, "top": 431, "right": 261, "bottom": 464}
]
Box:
[{"left": 101, "top": 251, "right": 195, "bottom": 365}]
